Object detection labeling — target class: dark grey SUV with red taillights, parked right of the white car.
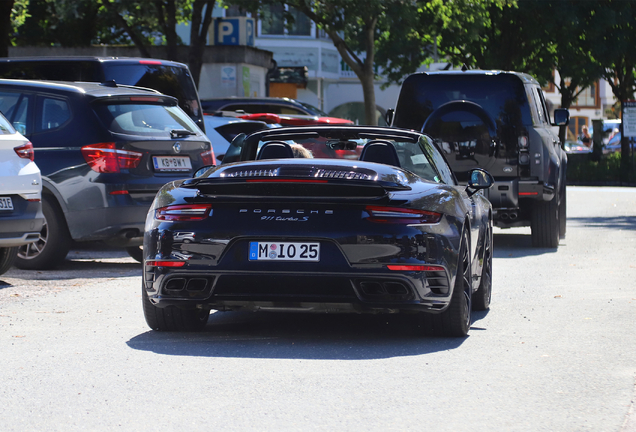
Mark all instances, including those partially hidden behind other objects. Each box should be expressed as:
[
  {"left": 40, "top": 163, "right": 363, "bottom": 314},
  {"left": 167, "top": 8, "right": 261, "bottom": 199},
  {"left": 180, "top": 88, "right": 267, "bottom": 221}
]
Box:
[{"left": 0, "top": 80, "right": 214, "bottom": 269}]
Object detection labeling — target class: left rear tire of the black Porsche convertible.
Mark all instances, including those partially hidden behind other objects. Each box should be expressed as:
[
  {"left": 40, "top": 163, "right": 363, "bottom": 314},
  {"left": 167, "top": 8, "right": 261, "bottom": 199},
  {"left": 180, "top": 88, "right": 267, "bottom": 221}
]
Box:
[{"left": 141, "top": 286, "right": 210, "bottom": 332}]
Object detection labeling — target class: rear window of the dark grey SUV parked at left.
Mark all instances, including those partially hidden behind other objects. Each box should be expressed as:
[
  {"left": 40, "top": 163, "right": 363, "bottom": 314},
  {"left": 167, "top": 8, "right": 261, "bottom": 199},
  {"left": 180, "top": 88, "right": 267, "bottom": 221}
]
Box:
[{"left": 95, "top": 104, "right": 200, "bottom": 137}]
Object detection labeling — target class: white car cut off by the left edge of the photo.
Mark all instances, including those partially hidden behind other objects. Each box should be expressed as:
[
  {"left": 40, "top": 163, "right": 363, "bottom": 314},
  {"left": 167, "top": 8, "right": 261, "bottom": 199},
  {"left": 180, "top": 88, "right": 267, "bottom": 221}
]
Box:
[{"left": 0, "top": 114, "right": 44, "bottom": 274}]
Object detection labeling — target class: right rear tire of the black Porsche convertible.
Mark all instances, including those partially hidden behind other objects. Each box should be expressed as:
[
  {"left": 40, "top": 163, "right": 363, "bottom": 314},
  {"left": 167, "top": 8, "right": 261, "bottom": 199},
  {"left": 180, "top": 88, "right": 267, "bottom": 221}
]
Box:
[{"left": 420, "top": 234, "right": 472, "bottom": 337}]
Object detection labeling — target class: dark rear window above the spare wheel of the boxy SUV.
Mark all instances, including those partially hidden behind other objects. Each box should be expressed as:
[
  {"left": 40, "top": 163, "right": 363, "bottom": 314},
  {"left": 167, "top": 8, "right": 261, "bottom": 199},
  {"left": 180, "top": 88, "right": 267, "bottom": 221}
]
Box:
[{"left": 394, "top": 74, "right": 532, "bottom": 131}]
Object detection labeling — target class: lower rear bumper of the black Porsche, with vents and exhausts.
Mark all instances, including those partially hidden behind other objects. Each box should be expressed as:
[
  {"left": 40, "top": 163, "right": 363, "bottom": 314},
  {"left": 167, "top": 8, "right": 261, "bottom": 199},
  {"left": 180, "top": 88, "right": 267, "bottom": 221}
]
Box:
[{"left": 143, "top": 267, "right": 450, "bottom": 313}]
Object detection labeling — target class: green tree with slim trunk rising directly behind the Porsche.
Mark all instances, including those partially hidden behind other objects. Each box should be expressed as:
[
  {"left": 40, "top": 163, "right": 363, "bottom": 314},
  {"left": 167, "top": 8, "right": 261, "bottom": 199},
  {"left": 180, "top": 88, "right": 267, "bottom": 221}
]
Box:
[{"left": 231, "top": 0, "right": 440, "bottom": 125}]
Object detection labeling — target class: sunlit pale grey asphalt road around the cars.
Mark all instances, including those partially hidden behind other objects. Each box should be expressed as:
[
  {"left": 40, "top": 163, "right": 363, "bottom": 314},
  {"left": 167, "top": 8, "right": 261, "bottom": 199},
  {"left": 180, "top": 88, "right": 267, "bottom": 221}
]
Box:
[{"left": 0, "top": 187, "right": 636, "bottom": 431}]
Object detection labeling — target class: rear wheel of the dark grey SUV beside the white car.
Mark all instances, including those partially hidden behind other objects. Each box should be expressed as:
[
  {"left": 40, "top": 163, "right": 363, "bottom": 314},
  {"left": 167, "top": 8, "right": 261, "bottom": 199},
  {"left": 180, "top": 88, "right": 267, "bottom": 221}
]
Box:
[{"left": 15, "top": 197, "right": 73, "bottom": 270}]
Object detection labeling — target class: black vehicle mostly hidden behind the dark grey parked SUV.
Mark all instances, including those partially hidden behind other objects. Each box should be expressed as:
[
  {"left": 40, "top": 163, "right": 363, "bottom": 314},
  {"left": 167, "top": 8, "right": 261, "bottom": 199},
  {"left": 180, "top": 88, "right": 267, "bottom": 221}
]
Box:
[{"left": 0, "top": 56, "right": 205, "bottom": 131}]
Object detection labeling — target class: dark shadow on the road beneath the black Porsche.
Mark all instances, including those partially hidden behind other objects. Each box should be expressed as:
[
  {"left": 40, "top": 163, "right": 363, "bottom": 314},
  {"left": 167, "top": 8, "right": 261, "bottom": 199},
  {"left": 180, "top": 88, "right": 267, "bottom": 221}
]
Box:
[{"left": 127, "top": 312, "right": 474, "bottom": 360}]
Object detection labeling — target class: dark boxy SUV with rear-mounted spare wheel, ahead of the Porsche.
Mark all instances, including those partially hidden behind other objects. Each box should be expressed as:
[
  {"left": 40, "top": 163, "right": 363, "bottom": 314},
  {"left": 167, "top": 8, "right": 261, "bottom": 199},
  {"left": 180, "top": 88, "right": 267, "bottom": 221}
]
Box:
[{"left": 392, "top": 70, "right": 569, "bottom": 248}]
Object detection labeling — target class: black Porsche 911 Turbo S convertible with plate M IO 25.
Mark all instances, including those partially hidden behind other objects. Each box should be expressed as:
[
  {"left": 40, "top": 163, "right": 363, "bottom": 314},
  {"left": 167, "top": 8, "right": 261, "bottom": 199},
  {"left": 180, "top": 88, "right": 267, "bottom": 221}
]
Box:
[{"left": 142, "top": 126, "right": 493, "bottom": 337}]
